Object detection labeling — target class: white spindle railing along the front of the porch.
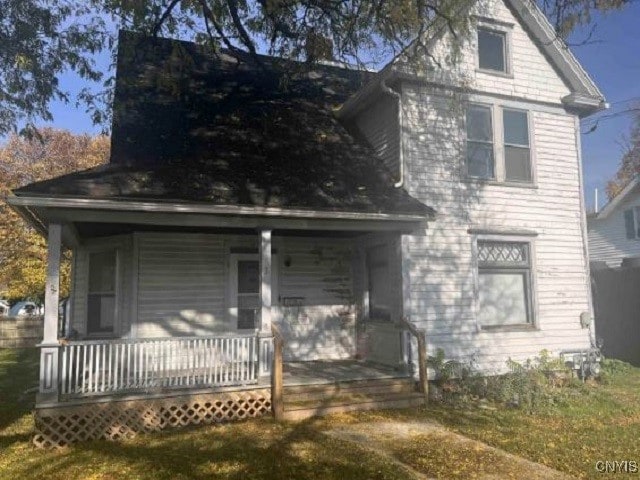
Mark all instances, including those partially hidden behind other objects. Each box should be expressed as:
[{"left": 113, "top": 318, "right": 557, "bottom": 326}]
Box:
[{"left": 60, "top": 334, "right": 262, "bottom": 397}]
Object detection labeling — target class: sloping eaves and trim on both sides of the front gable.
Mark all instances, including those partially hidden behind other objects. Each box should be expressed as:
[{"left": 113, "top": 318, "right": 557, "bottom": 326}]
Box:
[{"left": 339, "top": 0, "right": 607, "bottom": 118}]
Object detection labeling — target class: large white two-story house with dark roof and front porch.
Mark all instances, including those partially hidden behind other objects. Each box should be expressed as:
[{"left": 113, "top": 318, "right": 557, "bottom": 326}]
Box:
[{"left": 9, "top": 0, "right": 604, "bottom": 444}]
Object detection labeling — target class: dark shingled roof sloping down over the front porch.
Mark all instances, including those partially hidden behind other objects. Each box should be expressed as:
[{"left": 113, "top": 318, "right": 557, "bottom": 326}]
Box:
[{"left": 14, "top": 32, "right": 432, "bottom": 215}]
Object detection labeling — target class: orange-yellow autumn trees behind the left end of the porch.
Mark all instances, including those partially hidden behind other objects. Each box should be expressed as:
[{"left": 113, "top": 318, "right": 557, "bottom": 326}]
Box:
[{"left": 0, "top": 128, "right": 110, "bottom": 301}]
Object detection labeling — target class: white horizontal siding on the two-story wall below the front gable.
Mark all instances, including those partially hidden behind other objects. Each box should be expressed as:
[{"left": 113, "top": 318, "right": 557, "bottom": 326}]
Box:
[{"left": 403, "top": 84, "right": 592, "bottom": 371}]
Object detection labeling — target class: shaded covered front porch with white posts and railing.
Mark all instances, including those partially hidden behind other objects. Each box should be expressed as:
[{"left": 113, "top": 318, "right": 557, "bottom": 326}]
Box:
[{"left": 11, "top": 197, "right": 424, "bottom": 408}]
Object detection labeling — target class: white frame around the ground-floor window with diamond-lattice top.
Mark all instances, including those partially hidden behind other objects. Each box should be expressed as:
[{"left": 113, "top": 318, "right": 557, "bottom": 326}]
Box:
[{"left": 471, "top": 234, "right": 539, "bottom": 332}]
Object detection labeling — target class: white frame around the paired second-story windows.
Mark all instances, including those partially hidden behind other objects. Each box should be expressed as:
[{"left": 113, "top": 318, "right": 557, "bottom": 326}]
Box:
[{"left": 461, "top": 102, "right": 538, "bottom": 188}]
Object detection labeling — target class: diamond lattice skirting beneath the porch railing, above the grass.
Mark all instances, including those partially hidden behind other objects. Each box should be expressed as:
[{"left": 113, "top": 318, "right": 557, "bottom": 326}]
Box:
[{"left": 33, "top": 389, "right": 271, "bottom": 448}]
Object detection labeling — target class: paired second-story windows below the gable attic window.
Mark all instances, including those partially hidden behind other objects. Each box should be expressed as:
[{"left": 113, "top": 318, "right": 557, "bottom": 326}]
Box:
[{"left": 465, "top": 103, "right": 533, "bottom": 184}]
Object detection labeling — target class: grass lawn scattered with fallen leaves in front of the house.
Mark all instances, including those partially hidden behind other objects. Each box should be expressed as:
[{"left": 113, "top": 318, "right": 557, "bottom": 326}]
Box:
[{"left": 0, "top": 350, "right": 640, "bottom": 480}]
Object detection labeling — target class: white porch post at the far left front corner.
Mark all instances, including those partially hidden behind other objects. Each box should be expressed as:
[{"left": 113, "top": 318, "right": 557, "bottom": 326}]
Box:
[{"left": 37, "top": 223, "right": 62, "bottom": 403}]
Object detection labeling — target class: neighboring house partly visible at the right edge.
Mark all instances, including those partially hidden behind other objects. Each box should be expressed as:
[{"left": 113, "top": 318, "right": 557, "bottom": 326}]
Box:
[{"left": 587, "top": 176, "right": 640, "bottom": 267}]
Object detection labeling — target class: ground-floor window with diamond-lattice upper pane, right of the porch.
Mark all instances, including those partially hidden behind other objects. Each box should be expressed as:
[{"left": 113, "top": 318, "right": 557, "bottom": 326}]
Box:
[{"left": 477, "top": 240, "right": 533, "bottom": 328}]
